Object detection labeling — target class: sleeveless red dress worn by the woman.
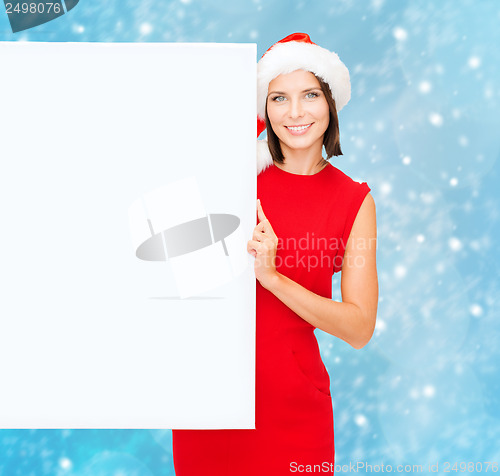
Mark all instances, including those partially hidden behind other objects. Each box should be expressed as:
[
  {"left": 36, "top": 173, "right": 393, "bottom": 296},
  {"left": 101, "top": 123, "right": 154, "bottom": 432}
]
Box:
[{"left": 172, "top": 164, "right": 370, "bottom": 476}]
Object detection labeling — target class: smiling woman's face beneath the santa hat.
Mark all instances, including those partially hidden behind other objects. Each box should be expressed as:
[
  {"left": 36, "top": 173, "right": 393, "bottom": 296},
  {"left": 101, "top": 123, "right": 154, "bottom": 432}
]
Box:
[{"left": 267, "top": 69, "right": 330, "bottom": 156}]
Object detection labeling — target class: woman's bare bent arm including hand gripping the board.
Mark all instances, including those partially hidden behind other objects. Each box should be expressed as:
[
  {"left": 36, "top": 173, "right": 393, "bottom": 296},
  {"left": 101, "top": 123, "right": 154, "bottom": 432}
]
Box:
[{"left": 249, "top": 193, "right": 378, "bottom": 349}]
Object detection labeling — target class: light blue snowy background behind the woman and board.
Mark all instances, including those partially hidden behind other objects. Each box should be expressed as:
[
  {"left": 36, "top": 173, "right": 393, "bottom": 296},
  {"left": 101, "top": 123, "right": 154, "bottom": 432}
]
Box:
[{"left": 0, "top": 0, "right": 500, "bottom": 476}]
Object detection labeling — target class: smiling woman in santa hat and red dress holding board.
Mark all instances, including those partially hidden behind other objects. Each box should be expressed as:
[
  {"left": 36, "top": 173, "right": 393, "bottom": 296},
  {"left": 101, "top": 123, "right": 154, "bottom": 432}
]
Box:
[{"left": 172, "top": 33, "right": 378, "bottom": 476}]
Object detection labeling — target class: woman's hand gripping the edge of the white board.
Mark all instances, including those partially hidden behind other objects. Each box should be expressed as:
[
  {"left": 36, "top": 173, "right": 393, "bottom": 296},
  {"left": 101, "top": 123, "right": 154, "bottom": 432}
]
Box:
[{"left": 247, "top": 200, "right": 278, "bottom": 288}]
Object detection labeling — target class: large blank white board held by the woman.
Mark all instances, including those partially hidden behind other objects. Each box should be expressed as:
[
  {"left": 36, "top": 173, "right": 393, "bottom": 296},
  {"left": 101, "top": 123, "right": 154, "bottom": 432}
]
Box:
[{"left": 0, "top": 42, "right": 256, "bottom": 429}]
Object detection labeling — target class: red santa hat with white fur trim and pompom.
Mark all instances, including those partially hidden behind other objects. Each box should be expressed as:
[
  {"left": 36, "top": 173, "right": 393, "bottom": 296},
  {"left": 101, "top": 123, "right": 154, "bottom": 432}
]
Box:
[{"left": 257, "top": 33, "right": 351, "bottom": 174}]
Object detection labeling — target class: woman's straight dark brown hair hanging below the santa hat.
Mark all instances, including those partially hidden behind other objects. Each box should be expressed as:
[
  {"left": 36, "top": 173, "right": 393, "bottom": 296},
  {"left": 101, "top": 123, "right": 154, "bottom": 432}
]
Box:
[{"left": 266, "top": 75, "right": 343, "bottom": 164}]
